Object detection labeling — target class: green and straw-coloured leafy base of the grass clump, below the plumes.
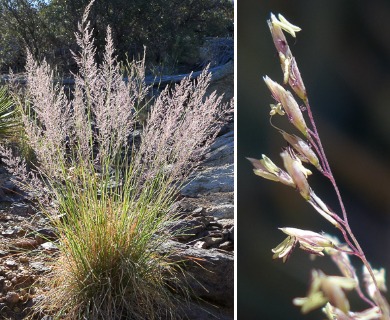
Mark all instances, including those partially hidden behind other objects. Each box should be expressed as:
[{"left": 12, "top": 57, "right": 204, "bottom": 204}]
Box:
[{"left": 43, "top": 158, "right": 185, "bottom": 319}]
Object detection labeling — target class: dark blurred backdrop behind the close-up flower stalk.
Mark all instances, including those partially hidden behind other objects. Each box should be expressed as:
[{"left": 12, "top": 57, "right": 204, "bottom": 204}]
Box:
[{"left": 237, "top": 0, "right": 390, "bottom": 320}]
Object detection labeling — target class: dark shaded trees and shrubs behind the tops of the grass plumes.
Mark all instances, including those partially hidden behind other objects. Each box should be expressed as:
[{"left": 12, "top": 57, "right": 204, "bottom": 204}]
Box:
[{"left": 0, "top": 0, "right": 233, "bottom": 72}]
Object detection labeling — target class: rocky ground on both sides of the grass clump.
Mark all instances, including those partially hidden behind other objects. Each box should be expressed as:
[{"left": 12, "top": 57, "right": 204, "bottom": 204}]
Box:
[{"left": 0, "top": 123, "right": 234, "bottom": 320}]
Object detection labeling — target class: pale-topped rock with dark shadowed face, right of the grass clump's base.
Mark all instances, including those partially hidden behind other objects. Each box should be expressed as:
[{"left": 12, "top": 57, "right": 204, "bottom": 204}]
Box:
[{"left": 161, "top": 241, "right": 234, "bottom": 307}]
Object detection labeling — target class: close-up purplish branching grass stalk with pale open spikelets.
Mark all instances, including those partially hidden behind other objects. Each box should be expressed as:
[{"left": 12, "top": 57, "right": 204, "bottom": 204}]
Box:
[{"left": 249, "top": 14, "right": 390, "bottom": 320}]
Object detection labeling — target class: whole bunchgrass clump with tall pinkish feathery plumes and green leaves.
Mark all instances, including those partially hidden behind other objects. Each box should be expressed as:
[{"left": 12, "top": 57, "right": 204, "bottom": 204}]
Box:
[{"left": 0, "top": 2, "right": 229, "bottom": 320}]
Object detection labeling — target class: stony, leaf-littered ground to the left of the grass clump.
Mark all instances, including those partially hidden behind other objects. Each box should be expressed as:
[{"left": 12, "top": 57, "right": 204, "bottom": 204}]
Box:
[{"left": 0, "top": 178, "right": 58, "bottom": 319}]
